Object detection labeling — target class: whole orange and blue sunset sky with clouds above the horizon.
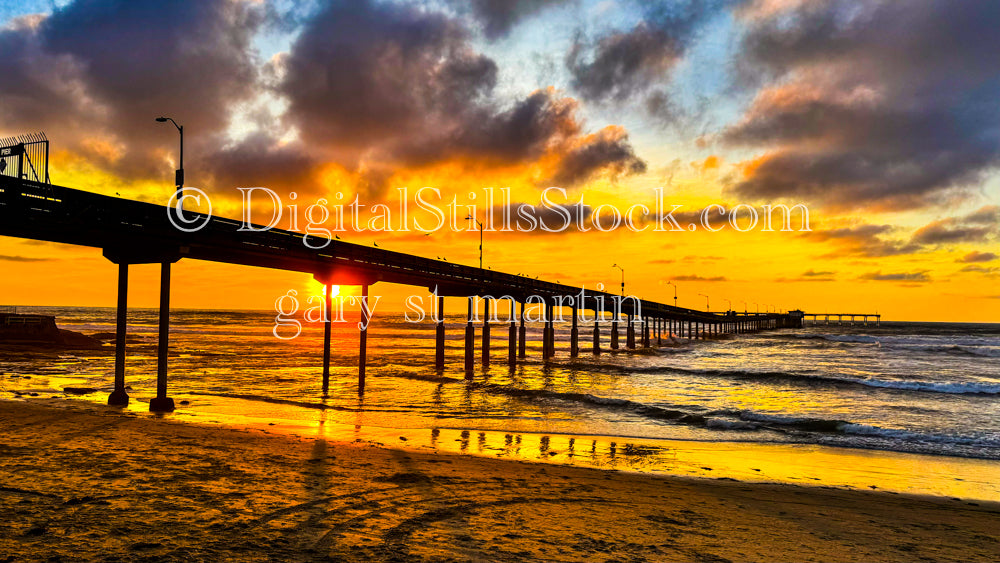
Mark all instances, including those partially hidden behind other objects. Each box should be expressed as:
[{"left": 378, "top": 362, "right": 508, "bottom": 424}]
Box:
[{"left": 0, "top": 0, "right": 1000, "bottom": 322}]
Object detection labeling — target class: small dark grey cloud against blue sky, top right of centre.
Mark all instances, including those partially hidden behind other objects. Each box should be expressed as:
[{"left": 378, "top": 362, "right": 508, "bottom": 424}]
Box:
[{"left": 566, "top": 0, "right": 737, "bottom": 117}]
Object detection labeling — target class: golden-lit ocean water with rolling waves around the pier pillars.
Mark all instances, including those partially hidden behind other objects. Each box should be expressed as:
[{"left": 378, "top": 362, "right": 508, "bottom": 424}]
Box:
[{"left": 0, "top": 307, "right": 1000, "bottom": 498}]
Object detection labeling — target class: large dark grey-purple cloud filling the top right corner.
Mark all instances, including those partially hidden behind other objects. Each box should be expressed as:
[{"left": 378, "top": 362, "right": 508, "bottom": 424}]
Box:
[{"left": 722, "top": 0, "right": 1000, "bottom": 209}]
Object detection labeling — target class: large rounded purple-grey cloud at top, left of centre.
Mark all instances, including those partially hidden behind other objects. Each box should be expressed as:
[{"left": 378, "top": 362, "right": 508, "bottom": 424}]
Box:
[{"left": 279, "top": 1, "right": 497, "bottom": 159}]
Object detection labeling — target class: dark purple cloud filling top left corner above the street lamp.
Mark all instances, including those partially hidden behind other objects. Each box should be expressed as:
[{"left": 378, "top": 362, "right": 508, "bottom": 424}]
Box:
[{"left": 0, "top": 0, "right": 265, "bottom": 177}]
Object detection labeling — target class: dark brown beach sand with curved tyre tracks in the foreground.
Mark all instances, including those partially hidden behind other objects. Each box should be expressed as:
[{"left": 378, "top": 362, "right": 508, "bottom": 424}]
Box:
[{"left": 0, "top": 401, "right": 1000, "bottom": 561}]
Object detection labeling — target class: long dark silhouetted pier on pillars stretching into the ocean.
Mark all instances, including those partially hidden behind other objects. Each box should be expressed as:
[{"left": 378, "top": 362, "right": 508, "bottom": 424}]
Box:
[{"left": 0, "top": 176, "right": 803, "bottom": 411}]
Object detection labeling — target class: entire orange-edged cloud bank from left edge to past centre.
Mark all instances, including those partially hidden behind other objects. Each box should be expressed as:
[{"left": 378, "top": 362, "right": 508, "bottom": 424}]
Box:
[{"left": 0, "top": 0, "right": 646, "bottom": 197}]
